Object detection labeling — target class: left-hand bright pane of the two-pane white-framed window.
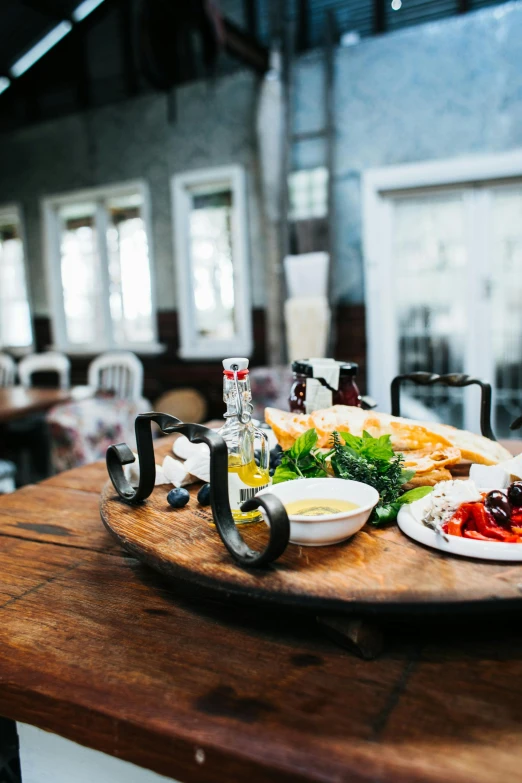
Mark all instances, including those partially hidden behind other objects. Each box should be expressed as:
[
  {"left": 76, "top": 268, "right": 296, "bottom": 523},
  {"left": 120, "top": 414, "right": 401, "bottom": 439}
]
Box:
[{"left": 60, "top": 204, "right": 105, "bottom": 345}]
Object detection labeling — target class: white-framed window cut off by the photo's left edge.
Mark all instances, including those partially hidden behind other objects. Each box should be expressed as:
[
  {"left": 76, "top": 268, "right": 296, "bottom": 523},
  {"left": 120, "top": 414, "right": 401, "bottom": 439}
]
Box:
[{"left": 0, "top": 207, "right": 33, "bottom": 350}]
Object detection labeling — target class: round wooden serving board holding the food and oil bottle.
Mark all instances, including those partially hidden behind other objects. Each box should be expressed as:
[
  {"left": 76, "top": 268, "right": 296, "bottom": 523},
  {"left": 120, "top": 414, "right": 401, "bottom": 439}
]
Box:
[{"left": 101, "top": 482, "right": 522, "bottom": 612}]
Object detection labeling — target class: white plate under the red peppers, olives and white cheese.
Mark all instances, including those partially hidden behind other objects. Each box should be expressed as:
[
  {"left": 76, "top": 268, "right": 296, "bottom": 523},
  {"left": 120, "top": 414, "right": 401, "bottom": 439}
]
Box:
[{"left": 397, "top": 495, "right": 522, "bottom": 563}]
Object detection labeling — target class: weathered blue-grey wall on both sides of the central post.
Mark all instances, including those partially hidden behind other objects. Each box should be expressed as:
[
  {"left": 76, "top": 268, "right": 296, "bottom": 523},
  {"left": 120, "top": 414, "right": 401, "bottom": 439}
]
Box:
[{"left": 0, "top": 2, "right": 522, "bottom": 314}]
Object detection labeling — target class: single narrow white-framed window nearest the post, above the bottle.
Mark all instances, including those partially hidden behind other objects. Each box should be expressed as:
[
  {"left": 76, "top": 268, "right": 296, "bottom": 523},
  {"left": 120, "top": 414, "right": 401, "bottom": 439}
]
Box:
[{"left": 172, "top": 166, "right": 252, "bottom": 359}]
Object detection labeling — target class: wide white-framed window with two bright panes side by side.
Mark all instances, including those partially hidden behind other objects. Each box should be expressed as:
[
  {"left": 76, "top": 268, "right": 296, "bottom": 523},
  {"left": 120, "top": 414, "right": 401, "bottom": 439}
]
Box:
[{"left": 44, "top": 182, "right": 159, "bottom": 353}]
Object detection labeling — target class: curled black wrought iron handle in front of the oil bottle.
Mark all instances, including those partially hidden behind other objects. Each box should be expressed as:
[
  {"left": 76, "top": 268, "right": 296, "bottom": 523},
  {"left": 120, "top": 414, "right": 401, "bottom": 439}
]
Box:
[{"left": 107, "top": 413, "right": 290, "bottom": 567}]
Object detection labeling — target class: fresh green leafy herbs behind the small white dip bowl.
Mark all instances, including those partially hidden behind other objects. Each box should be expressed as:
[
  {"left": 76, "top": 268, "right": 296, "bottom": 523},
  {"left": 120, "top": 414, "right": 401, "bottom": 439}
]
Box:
[{"left": 273, "top": 429, "right": 432, "bottom": 525}]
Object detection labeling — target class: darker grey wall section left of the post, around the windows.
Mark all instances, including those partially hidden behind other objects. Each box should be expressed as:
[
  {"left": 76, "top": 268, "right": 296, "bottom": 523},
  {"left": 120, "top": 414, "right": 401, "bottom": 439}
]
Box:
[{"left": 0, "top": 71, "right": 264, "bottom": 315}]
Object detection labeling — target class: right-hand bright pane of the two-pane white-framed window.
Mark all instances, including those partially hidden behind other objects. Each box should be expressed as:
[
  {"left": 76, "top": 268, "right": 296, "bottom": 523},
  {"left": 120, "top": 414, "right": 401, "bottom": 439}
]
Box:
[{"left": 107, "top": 194, "right": 154, "bottom": 345}]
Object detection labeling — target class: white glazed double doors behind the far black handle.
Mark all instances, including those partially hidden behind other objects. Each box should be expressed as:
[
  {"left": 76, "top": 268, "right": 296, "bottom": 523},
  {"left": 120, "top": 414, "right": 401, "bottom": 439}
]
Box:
[{"left": 367, "top": 176, "right": 522, "bottom": 438}]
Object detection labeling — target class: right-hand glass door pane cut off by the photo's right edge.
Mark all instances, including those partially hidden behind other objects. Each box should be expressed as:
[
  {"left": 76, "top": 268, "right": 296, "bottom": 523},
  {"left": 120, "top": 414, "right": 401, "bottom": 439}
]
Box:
[{"left": 490, "top": 186, "right": 522, "bottom": 438}]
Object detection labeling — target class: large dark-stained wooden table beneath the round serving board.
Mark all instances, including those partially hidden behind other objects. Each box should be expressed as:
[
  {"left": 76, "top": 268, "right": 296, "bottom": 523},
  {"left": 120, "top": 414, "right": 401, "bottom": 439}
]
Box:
[{"left": 0, "top": 443, "right": 522, "bottom": 783}]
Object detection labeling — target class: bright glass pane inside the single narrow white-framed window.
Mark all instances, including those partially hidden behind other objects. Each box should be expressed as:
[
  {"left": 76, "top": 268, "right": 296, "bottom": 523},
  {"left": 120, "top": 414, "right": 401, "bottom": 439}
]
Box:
[{"left": 190, "top": 190, "right": 236, "bottom": 340}]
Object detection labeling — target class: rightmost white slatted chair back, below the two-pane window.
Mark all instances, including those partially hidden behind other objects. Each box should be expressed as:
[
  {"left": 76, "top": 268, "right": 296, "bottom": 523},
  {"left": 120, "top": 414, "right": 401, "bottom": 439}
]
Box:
[{"left": 87, "top": 351, "right": 143, "bottom": 401}]
